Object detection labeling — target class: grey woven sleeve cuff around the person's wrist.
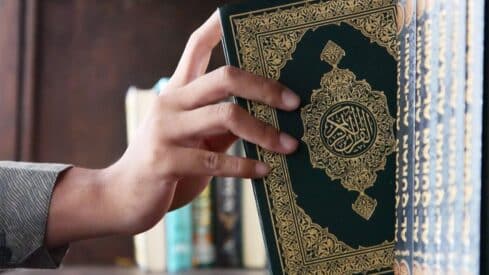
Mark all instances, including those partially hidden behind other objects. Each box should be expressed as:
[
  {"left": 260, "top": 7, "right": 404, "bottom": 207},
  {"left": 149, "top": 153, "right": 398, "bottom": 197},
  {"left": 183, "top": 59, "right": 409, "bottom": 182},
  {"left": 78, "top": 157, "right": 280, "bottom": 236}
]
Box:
[{"left": 0, "top": 162, "right": 70, "bottom": 268}]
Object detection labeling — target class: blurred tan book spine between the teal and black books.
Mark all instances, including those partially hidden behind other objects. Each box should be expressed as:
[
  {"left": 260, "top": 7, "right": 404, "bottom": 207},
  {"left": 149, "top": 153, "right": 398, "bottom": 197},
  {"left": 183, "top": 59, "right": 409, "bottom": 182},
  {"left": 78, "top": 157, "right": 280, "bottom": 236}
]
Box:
[{"left": 192, "top": 186, "right": 215, "bottom": 267}]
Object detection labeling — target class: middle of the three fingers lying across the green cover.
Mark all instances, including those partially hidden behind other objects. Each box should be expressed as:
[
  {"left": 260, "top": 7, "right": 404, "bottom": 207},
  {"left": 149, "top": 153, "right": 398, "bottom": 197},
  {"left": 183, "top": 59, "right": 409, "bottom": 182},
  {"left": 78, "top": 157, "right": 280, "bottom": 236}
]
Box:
[{"left": 176, "top": 103, "right": 298, "bottom": 154}]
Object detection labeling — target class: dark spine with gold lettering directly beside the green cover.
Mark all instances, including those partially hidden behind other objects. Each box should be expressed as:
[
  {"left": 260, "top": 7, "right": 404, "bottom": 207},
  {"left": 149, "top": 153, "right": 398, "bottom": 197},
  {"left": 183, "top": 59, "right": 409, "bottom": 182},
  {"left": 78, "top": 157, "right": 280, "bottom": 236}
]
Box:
[{"left": 394, "top": 0, "right": 416, "bottom": 274}]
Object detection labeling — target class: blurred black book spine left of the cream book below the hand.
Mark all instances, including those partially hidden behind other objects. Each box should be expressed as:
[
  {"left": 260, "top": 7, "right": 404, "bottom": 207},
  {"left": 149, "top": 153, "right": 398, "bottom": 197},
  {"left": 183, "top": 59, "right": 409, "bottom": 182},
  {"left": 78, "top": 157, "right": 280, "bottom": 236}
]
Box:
[{"left": 214, "top": 144, "right": 241, "bottom": 268}]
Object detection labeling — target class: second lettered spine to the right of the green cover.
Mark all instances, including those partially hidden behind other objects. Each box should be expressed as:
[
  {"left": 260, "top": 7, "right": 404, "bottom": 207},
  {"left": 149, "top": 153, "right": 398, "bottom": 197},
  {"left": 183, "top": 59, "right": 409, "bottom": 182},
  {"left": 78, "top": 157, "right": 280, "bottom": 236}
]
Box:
[{"left": 413, "top": 1, "right": 439, "bottom": 274}]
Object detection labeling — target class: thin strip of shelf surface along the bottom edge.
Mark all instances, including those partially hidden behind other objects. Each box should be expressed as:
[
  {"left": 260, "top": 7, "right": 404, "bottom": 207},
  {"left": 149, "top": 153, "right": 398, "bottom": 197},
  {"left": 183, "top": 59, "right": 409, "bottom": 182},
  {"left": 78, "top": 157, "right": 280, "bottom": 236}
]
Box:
[{"left": 0, "top": 267, "right": 268, "bottom": 275}]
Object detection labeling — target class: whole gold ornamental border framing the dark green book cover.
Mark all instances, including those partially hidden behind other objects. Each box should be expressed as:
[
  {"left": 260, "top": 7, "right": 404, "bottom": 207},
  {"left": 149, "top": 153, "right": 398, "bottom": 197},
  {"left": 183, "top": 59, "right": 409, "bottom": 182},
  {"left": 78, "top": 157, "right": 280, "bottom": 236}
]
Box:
[{"left": 229, "top": 0, "right": 398, "bottom": 274}]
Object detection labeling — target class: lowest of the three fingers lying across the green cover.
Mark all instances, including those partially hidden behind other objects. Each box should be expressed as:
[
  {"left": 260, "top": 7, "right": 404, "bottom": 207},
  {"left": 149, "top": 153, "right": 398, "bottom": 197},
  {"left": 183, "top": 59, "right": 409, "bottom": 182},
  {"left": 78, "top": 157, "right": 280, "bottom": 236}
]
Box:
[{"left": 170, "top": 147, "right": 270, "bottom": 178}]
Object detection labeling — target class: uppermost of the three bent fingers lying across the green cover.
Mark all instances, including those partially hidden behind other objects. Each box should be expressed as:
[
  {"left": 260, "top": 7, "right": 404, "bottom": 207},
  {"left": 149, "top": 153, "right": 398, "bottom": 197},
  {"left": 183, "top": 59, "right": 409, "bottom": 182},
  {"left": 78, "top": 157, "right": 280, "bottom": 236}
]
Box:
[{"left": 176, "top": 66, "right": 300, "bottom": 111}]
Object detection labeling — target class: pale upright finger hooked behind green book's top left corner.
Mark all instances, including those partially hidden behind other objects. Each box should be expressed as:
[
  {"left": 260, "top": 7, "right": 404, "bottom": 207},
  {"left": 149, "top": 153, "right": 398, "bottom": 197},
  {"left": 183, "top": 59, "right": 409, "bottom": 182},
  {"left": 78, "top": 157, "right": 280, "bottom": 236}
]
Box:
[{"left": 171, "top": 10, "right": 221, "bottom": 86}]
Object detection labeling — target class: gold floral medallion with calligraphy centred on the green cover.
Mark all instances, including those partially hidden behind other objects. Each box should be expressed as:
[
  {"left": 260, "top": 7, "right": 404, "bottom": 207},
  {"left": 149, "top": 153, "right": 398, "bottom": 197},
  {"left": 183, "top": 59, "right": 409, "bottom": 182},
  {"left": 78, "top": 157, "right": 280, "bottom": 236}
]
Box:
[{"left": 301, "top": 40, "right": 396, "bottom": 220}]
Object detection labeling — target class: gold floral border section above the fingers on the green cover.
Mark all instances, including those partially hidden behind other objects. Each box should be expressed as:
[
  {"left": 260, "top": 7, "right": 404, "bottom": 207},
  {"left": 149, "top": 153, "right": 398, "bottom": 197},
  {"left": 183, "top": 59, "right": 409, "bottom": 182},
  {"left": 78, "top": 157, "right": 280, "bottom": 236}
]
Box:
[{"left": 231, "top": 0, "right": 399, "bottom": 79}]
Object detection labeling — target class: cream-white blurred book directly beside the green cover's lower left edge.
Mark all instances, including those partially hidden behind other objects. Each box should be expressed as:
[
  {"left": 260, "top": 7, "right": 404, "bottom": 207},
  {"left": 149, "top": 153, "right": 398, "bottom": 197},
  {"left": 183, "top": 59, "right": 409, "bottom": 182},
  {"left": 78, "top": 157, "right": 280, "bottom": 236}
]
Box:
[{"left": 241, "top": 179, "right": 267, "bottom": 269}]
